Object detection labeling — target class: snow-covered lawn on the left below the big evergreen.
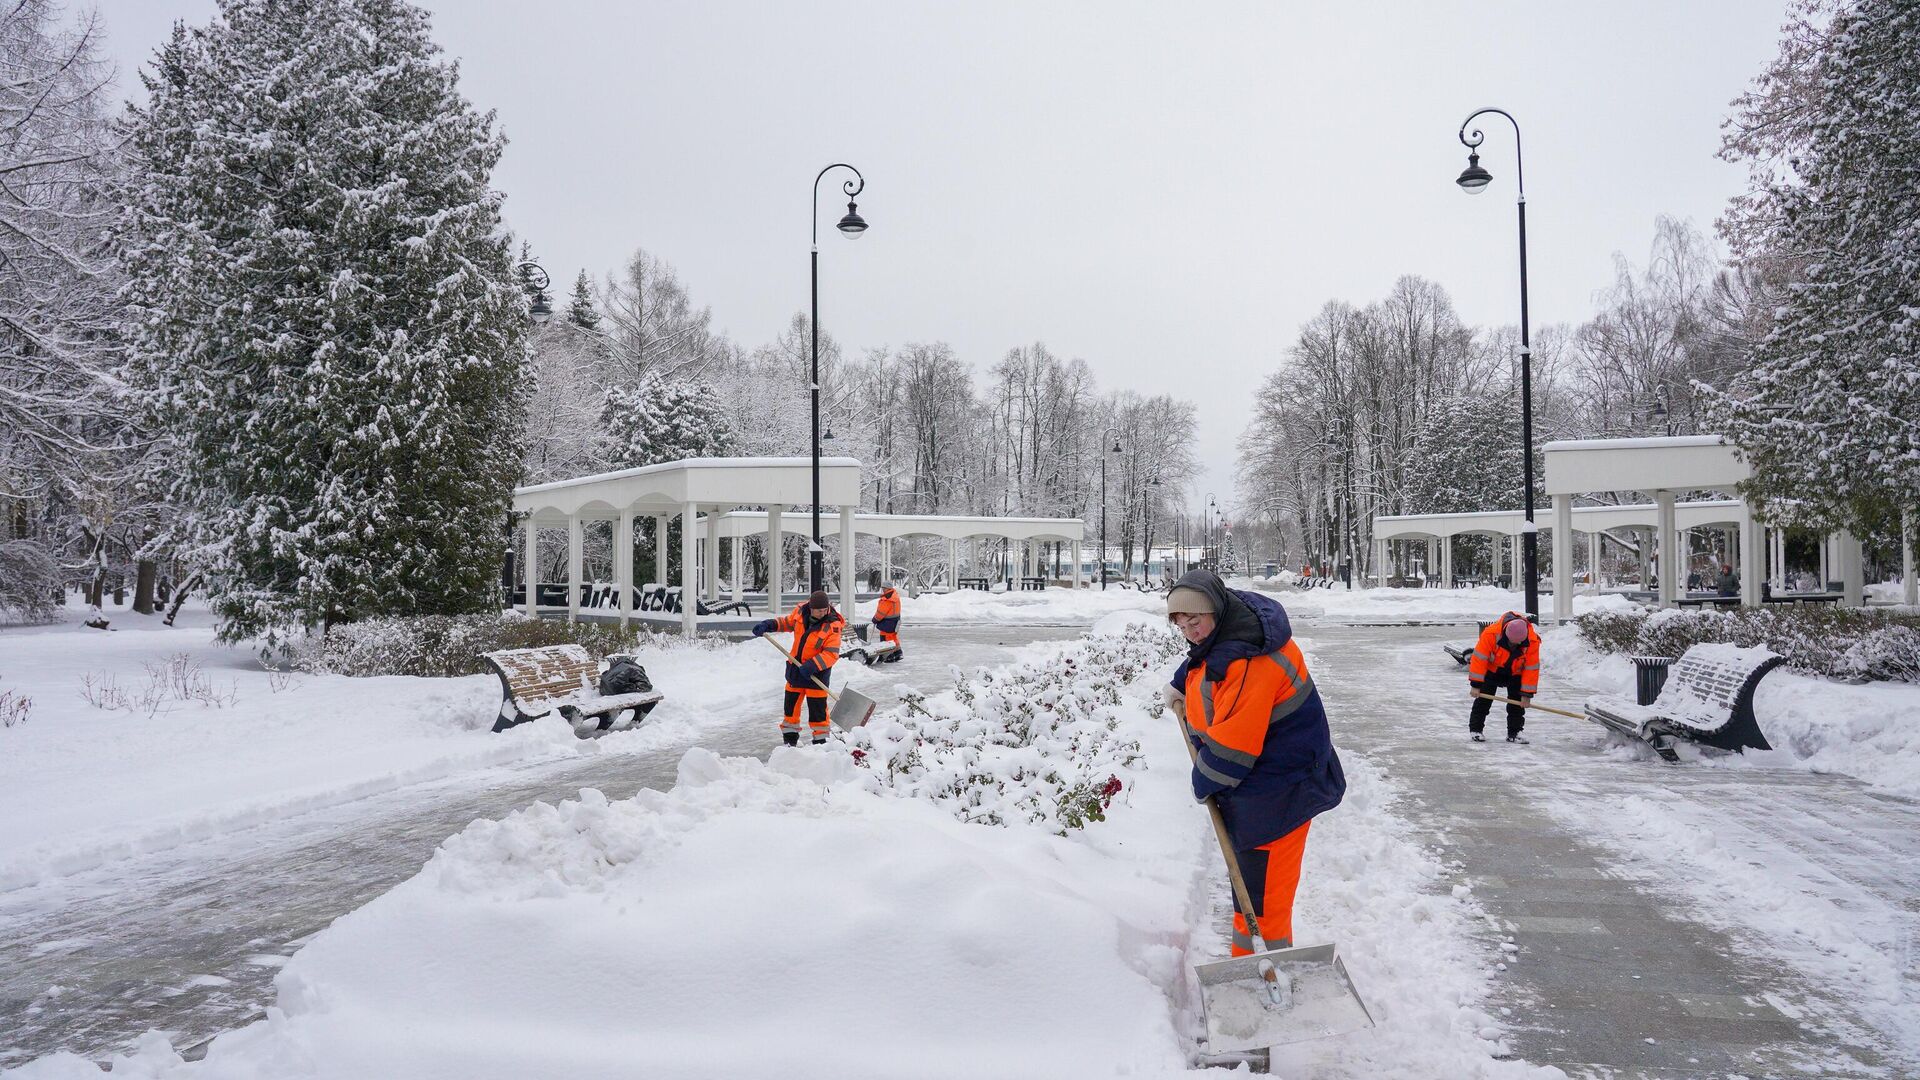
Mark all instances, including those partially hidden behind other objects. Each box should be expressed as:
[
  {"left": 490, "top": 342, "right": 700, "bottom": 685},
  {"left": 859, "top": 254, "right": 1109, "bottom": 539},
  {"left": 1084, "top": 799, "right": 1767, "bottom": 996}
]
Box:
[{"left": 0, "top": 609, "right": 780, "bottom": 890}]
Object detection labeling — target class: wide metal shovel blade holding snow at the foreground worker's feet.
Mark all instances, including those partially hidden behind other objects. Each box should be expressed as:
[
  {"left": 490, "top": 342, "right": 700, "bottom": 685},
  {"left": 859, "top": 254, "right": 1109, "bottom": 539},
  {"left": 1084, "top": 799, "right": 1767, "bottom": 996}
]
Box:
[{"left": 1194, "top": 945, "right": 1373, "bottom": 1053}]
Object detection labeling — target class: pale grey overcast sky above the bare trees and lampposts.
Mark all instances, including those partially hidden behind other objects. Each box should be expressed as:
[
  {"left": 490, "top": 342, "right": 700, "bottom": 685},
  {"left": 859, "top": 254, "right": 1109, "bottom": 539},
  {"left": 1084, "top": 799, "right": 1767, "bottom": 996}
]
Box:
[{"left": 100, "top": 0, "right": 1784, "bottom": 518}]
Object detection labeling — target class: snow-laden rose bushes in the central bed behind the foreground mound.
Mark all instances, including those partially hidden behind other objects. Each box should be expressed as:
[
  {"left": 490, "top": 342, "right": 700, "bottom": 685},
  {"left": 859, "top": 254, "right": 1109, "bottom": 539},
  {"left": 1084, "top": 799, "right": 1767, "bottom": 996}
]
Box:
[{"left": 849, "top": 625, "right": 1185, "bottom": 834}]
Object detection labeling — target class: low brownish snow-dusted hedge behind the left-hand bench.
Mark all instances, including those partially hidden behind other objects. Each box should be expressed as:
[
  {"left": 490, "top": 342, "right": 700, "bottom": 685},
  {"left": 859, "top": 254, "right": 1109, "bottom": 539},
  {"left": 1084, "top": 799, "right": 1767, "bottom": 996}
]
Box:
[{"left": 288, "top": 613, "right": 702, "bottom": 678}]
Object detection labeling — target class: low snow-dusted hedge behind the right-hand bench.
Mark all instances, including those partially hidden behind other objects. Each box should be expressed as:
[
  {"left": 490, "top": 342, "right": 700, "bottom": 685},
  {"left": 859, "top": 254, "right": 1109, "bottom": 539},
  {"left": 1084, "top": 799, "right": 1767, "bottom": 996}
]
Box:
[{"left": 1574, "top": 605, "right": 1920, "bottom": 682}]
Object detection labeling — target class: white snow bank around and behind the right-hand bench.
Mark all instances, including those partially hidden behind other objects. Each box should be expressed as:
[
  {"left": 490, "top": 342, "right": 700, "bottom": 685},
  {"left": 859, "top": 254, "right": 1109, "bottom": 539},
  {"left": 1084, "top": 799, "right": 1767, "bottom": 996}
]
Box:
[{"left": 1542, "top": 626, "right": 1920, "bottom": 798}]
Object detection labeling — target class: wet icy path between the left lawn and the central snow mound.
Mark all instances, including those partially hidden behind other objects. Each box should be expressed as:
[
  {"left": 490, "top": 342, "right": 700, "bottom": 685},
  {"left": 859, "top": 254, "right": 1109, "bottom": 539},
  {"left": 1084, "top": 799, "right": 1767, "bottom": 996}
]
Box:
[{"left": 0, "top": 626, "right": 1083, "bottom": 1067}]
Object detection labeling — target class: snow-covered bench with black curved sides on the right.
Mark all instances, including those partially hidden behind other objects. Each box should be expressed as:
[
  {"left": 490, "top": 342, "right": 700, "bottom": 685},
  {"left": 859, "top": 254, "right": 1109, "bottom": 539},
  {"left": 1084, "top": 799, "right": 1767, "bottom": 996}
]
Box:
[{"left": 1584, "top": 644, "right": 1786, "bottom": 761}]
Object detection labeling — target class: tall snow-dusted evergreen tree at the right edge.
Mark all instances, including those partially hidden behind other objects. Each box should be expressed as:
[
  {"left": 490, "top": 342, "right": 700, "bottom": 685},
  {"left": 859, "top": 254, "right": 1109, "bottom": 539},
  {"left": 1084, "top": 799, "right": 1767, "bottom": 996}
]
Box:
[{"left": 1715, "top": 0, "right": 1920, "bottom": 540}]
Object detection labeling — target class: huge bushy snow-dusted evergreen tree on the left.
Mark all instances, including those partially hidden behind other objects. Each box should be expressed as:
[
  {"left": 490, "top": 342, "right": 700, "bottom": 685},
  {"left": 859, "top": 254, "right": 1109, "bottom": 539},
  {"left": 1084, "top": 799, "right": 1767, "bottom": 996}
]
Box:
[{"left": 123, "top": 0, "right": 526, "bottom": 648}]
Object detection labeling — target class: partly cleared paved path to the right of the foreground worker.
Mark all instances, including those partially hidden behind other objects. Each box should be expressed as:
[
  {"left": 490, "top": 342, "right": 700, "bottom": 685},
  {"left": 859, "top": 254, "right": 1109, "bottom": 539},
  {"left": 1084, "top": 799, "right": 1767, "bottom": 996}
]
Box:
[{"left": 1300, "top": 625, "right": 1920, "bottom": 1078}]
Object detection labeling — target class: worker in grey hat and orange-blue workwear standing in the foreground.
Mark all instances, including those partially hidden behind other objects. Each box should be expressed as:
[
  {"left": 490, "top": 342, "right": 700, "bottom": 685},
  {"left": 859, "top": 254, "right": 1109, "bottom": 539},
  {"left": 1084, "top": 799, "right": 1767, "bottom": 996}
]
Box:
[{"left": 1165, "top": 571, "right": 1346, "bottom": 957}]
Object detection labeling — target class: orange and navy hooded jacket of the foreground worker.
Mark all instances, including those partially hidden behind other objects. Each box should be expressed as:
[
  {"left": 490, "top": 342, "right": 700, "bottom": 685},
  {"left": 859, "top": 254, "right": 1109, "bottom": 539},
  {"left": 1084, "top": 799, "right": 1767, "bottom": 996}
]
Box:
[{"left": 1173, "top": 575, "right": 1346, "bottom": 851}]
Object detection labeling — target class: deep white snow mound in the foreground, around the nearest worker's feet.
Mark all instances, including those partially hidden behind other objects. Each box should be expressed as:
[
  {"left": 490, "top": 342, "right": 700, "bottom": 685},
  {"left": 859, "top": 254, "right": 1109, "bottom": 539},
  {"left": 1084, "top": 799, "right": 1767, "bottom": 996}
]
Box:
[{"left": 17, "top": 615, "right": 1559, "bottom": 1080}]
